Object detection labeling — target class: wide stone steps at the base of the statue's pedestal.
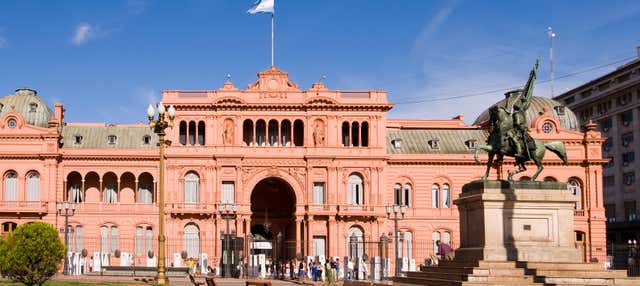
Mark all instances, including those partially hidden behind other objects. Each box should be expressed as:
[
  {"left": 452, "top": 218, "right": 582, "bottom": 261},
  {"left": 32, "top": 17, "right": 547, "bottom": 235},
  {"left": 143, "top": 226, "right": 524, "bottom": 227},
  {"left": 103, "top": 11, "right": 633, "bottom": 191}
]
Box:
[{"left": 393, "top": 260, "right": 640, "bottom": 286}]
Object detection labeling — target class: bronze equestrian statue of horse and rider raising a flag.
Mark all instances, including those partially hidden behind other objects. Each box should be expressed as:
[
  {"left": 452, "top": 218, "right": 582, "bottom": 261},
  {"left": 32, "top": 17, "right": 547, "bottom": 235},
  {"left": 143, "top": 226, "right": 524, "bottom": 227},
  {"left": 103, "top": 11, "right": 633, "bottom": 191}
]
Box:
[{"left": 474, "top": 60, "right": 567, "bottom": 181}]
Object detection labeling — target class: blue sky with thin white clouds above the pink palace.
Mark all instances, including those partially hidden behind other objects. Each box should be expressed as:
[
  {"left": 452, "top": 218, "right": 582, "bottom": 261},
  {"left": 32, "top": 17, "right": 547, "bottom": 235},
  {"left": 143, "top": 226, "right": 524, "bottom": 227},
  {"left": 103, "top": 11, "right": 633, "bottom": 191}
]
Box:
[{"left": 0, "top": 0, "right": 640, "bottom": 123}]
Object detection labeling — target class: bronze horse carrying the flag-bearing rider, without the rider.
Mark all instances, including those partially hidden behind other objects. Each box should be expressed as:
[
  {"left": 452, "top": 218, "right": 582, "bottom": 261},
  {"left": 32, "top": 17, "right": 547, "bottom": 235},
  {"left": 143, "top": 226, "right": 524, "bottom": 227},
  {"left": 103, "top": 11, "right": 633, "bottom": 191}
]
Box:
[{"left": 474, "top": 105, "right": 567, "bottom": 181}]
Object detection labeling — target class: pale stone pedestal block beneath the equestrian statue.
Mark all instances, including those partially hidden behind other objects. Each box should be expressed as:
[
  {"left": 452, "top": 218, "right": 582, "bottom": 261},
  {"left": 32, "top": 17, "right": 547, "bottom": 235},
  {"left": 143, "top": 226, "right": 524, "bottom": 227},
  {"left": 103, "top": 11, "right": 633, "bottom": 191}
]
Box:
[{"left": 454, "top": 181, "right": 581, "bottom": 262}]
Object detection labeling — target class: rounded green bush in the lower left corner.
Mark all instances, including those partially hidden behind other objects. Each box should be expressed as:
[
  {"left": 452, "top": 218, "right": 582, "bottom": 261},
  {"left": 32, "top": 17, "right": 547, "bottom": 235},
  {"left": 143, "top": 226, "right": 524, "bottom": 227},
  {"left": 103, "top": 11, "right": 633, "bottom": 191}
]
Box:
[{"left": 0, "top": 222, "right": 65, "bottom": 286}]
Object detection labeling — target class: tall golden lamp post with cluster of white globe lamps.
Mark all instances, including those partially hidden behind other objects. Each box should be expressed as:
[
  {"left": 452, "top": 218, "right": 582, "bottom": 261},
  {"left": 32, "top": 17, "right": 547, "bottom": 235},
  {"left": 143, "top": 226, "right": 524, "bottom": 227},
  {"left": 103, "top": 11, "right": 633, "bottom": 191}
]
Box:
[{"left": 147, "top": 102, "right": 176, "bottom": 285}]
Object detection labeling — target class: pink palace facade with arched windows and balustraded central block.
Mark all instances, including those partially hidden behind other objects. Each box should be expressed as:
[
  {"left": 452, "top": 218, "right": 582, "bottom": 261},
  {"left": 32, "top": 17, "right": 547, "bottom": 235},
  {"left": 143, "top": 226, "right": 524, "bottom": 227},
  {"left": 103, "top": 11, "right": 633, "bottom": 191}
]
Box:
[{"left": 0, "top": 68, "right": 606, "bottom": 271}]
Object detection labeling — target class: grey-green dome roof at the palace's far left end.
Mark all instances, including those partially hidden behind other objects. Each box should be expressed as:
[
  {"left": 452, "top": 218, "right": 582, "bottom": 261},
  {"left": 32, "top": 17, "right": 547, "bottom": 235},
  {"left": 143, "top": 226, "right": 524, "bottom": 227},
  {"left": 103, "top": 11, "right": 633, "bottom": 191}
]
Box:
[{"left": 0, "top": 87, "right": 53, "bottom": 128}]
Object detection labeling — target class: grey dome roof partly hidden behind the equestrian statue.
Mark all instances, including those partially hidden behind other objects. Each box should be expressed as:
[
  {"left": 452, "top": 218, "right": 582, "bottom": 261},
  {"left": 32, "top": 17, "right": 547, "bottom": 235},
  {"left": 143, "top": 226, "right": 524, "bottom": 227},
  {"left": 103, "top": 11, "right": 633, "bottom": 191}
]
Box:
[{"left": 473, "top": 96, "right": 580, "bottom": 131}]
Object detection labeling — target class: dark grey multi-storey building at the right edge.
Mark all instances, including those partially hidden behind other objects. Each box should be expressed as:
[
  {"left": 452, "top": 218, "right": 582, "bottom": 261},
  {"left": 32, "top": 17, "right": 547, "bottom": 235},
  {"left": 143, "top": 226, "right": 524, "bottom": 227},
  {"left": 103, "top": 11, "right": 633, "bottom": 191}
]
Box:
[{"left": 555, "top": 48, "right": 640, "bottom": 243}]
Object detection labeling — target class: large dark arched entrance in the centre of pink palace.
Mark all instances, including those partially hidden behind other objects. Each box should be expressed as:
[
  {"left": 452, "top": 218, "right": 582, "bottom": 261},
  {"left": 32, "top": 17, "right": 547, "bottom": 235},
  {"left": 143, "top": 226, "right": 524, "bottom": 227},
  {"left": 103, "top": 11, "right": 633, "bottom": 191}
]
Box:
[{"left": 250, "top": 177, "right": 296, "bottom": 262}]
